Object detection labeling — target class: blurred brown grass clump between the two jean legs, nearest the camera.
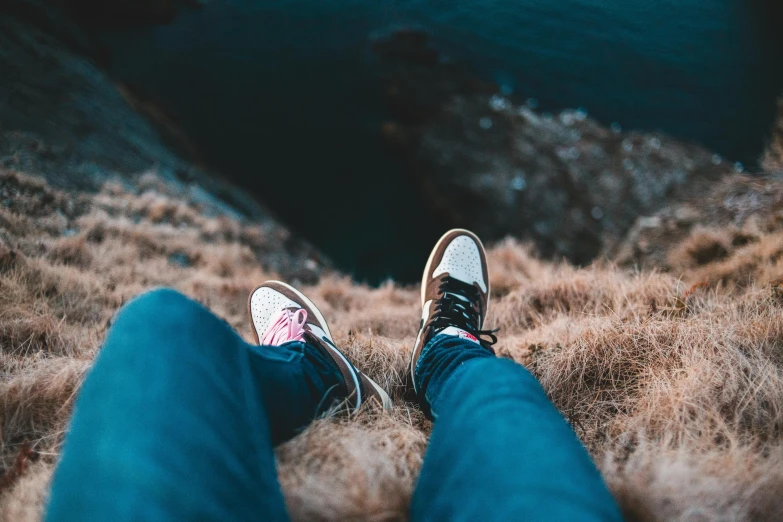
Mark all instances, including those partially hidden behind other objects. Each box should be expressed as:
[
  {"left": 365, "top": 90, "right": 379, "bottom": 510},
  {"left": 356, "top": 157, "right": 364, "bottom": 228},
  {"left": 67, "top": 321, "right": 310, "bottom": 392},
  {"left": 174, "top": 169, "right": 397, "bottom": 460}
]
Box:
[{"left": 278, "top": 407, "right": 427, "bottom": 522}]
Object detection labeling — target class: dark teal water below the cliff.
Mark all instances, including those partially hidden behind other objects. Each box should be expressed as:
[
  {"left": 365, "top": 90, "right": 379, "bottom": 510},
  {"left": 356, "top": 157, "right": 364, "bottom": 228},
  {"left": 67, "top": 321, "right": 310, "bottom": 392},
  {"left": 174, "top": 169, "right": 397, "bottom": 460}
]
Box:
[{"left": 102, "top": 0, "right": 783, "bottom": 282}]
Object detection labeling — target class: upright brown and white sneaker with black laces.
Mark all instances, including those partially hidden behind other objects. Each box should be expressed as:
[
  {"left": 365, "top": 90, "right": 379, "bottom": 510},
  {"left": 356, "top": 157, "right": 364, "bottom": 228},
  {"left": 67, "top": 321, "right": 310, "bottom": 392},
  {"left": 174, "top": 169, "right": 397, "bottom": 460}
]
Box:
[{"left": 411, "top": 229, "right": 497, "bottom": 391}]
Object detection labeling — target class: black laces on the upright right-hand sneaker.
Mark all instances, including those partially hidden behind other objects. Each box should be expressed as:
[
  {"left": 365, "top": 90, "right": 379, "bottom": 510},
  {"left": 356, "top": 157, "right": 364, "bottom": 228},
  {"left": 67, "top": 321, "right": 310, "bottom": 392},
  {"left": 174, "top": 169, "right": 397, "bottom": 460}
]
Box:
[{"left": 428, "top": 276, "right": 498, "bottom": 353}]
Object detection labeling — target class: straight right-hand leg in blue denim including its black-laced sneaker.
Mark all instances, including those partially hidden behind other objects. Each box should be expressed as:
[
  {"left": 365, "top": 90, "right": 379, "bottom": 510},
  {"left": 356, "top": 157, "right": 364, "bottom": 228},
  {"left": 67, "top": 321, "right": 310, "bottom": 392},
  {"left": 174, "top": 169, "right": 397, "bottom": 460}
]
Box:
[{"left": 411, "top": 230, "right": 621, "bottom": 522}]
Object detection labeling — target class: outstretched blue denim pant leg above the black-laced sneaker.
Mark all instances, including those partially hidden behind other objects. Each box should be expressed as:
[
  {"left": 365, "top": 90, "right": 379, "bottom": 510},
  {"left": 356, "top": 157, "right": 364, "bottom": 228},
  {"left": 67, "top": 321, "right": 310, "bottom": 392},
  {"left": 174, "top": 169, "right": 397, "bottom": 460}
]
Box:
[{"left": 411, "top": 335, "right": 622, "bottom": 522}]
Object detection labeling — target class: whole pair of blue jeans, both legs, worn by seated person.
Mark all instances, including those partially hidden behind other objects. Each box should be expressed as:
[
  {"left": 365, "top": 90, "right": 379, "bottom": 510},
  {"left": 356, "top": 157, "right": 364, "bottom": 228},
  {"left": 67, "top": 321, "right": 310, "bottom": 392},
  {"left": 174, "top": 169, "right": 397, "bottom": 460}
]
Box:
[{"left": 46, "top": 290, "right": 620, "bottom": 522}]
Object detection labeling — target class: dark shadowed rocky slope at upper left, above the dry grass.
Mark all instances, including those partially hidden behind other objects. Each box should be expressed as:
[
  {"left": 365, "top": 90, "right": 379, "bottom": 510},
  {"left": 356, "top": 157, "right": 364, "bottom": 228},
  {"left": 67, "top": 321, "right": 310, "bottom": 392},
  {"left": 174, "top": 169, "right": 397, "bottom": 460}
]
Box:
[{"left": 0, "top": 0, "right": 325, "bottom": 280}]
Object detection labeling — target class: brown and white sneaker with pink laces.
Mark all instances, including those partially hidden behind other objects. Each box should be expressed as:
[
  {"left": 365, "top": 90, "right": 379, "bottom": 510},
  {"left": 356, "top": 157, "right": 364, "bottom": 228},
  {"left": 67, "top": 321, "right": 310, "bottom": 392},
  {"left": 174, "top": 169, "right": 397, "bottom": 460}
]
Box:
[{"left": 247, "top": 281, "right": 392, "bottom": 411}]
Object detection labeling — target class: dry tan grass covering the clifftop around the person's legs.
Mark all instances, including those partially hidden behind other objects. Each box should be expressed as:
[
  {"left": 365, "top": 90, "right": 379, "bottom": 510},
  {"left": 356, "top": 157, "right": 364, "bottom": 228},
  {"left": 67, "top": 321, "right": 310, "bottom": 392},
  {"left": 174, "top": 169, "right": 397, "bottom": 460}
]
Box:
[{"left": 0, "top": 169, "right": 783, "bottom": 521}]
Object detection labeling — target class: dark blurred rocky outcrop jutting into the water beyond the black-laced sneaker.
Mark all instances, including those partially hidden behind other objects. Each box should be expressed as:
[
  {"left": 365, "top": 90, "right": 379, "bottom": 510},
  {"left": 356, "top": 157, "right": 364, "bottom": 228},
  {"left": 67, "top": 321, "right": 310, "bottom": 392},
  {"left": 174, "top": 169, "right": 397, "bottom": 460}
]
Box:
[{"left": 375, "top": 31, "right": 734, "bottom": 263}]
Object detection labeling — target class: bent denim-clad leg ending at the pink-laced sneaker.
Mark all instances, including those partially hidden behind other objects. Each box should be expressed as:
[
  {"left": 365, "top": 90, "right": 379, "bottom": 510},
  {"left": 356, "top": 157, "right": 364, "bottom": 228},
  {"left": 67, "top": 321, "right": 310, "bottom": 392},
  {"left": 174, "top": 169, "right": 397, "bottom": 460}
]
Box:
[{"left": 47, "top": 290, "right": 342, "bottom": 522}]
